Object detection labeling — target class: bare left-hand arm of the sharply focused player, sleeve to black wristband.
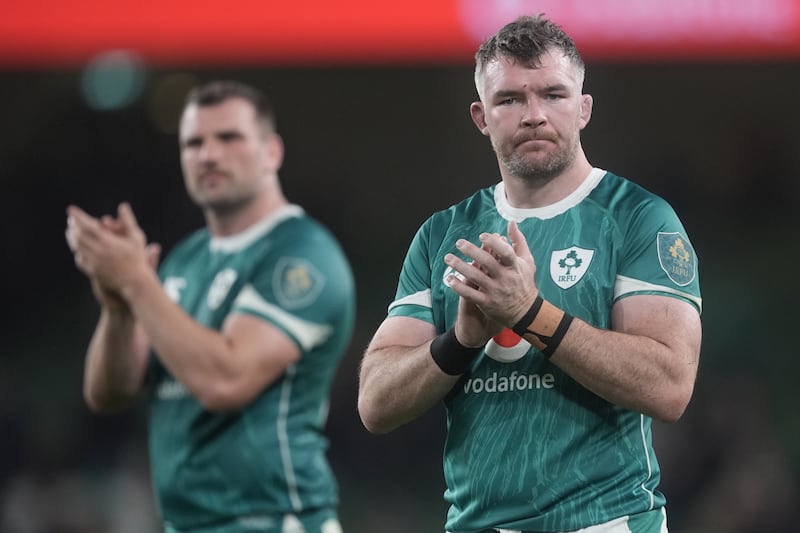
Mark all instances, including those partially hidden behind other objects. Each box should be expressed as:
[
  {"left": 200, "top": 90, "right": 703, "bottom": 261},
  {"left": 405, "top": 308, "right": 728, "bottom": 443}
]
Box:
[{"left": 358, "top": 317, "right": 459, "bottom": 433}]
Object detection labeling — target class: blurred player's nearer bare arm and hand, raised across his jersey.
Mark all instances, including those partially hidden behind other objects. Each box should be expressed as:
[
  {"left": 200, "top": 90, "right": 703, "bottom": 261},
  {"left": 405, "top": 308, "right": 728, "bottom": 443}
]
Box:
[{"left": 69, "top": 205, "right": 300, "bottom": 411}]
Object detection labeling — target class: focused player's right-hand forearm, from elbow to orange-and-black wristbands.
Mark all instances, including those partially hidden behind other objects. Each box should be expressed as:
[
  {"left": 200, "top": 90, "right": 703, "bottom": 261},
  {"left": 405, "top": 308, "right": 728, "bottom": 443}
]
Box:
[{"left": 551, "top": 319, "right": 698, "bottom": 421}]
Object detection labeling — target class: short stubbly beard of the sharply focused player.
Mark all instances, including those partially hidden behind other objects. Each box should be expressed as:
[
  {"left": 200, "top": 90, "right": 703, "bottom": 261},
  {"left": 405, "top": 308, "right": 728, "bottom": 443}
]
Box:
[{"left": 492, "top": 131, "right": 578, "bottom": 185}]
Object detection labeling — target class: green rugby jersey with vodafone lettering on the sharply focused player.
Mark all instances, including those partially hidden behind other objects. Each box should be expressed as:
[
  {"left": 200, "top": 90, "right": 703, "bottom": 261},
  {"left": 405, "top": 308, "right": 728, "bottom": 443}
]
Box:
[{"left": 389, "top": 169, "right": 701, "bottom": 533}]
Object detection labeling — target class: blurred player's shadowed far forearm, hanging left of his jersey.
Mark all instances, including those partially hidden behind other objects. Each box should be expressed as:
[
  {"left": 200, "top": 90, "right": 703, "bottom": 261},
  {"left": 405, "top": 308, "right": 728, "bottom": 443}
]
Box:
[{"left": 83, "top": 308, "right": 148, "bottom": 411}]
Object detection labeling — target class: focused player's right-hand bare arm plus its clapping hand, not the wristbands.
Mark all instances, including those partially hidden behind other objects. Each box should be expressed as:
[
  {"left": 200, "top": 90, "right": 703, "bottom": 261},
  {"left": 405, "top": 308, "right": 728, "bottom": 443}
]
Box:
[{"left": 445, "top": 223, "right": 701, "bottom": 421}]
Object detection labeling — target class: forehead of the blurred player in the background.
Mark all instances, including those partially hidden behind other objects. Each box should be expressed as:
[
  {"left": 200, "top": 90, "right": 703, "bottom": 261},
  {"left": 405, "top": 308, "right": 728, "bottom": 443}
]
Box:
[{"left": 180, "top": 97, "right": 257, "bottom": 138}]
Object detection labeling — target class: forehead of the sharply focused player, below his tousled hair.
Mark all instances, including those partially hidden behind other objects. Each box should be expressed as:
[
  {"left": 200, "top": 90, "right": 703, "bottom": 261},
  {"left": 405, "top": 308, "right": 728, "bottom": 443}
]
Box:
[{"left": 483, "top": 50, "right": 581, "bottom": 96}]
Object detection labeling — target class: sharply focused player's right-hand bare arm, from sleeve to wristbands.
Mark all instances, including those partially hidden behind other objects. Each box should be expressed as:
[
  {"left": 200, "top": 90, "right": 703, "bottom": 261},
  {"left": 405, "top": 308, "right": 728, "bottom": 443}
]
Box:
[{"left": 552, "top": 296, "right": 701, "bottom": 422}]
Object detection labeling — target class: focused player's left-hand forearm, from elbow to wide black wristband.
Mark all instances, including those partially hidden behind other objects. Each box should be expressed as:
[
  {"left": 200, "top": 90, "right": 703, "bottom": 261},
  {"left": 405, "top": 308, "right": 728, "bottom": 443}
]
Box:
[{"left": 358, "top": 342, "right": 460, "bottom": 433}]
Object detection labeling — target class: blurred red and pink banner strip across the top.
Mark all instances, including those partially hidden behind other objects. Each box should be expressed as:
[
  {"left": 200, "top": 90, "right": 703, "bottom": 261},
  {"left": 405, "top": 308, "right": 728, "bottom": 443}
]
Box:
[{"left": 0, "top": 0, "right": 800, "bottom": 68}]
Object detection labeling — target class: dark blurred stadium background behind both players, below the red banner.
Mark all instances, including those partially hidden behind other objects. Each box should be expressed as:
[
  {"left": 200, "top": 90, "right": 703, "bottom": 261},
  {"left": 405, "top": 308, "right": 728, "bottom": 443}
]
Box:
[{"left": 0, "top": 1, "right": 800, "bottom": 533}]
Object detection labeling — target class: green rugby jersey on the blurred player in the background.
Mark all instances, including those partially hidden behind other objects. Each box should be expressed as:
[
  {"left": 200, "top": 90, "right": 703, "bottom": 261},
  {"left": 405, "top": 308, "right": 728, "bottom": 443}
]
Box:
[{"left": 148, "top": 205, "right": 355, "bottom": 531}]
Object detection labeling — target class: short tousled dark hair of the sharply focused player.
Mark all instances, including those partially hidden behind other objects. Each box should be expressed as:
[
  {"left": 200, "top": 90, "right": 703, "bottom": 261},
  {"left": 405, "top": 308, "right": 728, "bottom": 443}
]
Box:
[{"left": 475, "top": 13, "right": 586, "bottom": 95}]
